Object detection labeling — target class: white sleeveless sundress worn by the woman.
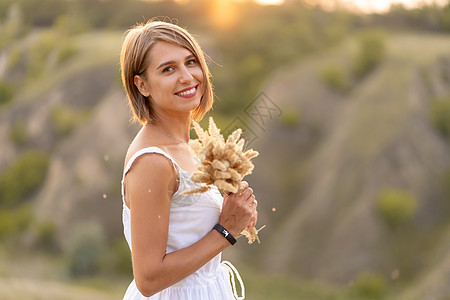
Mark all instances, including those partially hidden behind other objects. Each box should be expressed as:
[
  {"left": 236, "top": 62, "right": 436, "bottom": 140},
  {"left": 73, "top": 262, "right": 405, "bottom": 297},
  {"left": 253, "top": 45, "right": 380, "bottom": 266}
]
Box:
[{"left": 121, "top": 147, "right": 245, "bottom": 300}]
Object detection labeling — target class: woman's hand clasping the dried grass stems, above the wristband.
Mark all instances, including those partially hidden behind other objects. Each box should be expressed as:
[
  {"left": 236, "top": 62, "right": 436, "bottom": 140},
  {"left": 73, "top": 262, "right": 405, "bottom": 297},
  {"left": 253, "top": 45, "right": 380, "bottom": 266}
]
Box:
[{"left": 219, "top": 181, "right": 258, "bottom": 237}]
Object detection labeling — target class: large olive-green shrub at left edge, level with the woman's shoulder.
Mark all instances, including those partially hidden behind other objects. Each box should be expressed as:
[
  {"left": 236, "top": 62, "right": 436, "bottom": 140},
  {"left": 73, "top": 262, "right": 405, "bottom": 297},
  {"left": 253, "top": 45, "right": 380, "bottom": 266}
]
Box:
[{"left": 0, "top": 150, "right": 50, "bottom": 206}]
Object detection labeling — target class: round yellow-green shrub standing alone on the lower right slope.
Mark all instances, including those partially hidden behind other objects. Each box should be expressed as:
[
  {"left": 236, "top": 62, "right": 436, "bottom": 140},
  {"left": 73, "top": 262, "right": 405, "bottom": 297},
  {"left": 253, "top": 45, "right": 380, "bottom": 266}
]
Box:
[{"left": 377, "top": 188, "right": 418, "bottom": 228}]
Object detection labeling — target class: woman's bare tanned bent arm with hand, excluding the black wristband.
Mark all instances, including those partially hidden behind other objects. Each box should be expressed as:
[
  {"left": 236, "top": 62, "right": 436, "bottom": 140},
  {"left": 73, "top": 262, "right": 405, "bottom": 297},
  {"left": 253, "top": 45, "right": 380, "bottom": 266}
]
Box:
[{"left": 125, "top": 154, "right": 256, "bottom": 297}]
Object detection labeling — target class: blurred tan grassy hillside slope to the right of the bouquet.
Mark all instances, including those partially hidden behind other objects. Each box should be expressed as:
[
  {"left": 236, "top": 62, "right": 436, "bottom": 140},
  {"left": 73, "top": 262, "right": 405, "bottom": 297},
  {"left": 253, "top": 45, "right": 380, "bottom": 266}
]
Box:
[{"left": 252, "top": 34, "right": 450, "bottom": 299}]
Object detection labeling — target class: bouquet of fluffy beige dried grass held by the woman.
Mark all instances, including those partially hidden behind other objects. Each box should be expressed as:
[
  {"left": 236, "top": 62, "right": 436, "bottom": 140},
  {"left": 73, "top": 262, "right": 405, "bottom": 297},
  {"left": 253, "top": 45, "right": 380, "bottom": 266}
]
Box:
[{"left": 184, "top": 117, "right": 262, "bottom": 244}]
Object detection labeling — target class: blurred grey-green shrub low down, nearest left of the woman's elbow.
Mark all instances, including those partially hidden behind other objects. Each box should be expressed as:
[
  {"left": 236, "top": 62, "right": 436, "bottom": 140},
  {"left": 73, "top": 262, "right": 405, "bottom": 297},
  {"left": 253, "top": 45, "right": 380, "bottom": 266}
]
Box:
[{"left": 66, "top": 222, "right": 106, "bottom": 277}]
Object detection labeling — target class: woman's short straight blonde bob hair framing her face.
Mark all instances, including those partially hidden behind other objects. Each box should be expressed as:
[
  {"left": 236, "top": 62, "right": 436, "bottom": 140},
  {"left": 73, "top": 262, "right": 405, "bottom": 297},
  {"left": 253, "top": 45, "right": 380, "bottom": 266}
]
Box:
[{"left": 120, "top": 20, "right": 214, "bottom": 124}]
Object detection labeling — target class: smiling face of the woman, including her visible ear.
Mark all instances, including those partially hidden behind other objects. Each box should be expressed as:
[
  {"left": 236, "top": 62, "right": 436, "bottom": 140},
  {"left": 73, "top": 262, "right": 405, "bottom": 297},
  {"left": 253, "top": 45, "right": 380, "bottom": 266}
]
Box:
[{"left": 135, "top": 41, "right": 204, "bottom": 115}]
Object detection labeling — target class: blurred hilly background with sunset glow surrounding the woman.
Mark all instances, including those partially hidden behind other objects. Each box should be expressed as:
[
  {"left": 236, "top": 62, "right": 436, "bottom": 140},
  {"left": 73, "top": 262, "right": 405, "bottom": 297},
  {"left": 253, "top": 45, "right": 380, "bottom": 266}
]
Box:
[{"left": 0, "top": 0, "right": 450, "bottom": 300}]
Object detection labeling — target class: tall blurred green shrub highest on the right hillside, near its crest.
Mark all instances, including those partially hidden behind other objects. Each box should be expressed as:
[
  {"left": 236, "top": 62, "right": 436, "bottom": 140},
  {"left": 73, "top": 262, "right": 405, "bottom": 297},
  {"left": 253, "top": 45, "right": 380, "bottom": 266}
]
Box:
[{"left": 353, "top": 29, "right": 386, "bottom": 78}]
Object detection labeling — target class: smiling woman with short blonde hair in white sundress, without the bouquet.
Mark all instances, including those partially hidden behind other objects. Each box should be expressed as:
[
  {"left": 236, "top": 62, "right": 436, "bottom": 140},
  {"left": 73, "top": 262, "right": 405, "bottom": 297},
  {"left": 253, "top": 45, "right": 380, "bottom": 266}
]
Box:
[{"left": 120, "top": 21, "right": 257, "bottom": 300}]
